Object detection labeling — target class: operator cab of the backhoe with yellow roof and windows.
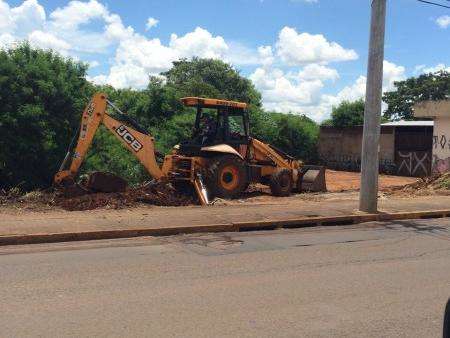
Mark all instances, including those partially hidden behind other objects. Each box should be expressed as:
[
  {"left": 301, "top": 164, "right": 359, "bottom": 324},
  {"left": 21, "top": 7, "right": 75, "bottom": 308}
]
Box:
[{"left": 180, "top": 97, "right": 250, "bottom": 153}]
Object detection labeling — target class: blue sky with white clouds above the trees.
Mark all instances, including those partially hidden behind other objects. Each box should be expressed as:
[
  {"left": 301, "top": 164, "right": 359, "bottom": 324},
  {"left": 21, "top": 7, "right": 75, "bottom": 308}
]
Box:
[{"left": 0, "top": 0, "right": 450, "bottom": 122}]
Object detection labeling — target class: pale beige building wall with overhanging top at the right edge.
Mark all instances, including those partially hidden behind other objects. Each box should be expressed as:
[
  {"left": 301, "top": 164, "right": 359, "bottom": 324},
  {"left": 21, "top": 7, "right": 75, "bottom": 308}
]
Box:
[{"left": 414, "top": 100, "right": 450, "bottom": 173}]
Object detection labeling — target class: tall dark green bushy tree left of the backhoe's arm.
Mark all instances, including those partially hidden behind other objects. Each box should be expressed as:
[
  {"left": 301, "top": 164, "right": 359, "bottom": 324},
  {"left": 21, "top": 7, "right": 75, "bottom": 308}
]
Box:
[{"left": 0, "top": 44, "right": 92, "bottom": 189}]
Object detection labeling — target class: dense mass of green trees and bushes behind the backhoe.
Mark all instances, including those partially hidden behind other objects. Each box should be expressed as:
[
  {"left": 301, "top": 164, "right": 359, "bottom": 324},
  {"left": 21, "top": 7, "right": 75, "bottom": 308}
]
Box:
[{"left": 0, "top": 44, "right": 318, "bottom": 190}]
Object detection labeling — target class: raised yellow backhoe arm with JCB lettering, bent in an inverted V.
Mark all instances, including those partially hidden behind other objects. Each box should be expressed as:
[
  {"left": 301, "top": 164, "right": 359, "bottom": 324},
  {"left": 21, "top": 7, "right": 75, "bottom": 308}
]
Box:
[{"left": 54, "top": 93, "right": 164, "bottom": 185}]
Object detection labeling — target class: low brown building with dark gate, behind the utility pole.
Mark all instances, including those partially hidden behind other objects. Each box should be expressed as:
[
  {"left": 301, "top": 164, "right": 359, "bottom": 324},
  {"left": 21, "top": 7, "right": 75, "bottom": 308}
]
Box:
[{"left": 319, "top": 121, "right": 434, "bottom": 177}]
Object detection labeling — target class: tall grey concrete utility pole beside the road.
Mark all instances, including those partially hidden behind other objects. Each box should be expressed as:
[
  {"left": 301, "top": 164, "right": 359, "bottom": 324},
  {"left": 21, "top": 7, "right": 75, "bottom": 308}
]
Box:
[{"left": 359, "top": 0, "right": 386, "bottom": 213}]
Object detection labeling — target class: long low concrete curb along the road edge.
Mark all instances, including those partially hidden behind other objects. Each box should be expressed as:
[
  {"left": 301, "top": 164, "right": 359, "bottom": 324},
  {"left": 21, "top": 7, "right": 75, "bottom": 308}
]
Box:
[{"left": 0, "top": 209, "right": 450, "bottom": 246}]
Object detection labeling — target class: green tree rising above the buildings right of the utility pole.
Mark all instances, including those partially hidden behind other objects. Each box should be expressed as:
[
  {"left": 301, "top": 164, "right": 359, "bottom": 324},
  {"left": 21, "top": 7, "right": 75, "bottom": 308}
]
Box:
[{"left": 383, "top": 71, "right": 450, "bottom": 120}]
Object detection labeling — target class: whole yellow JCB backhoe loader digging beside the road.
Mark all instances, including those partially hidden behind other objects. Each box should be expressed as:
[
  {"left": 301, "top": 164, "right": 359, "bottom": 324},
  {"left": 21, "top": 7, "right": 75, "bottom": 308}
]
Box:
[{"left": 54, "top": 93, "right": 326, "bottom": 205}]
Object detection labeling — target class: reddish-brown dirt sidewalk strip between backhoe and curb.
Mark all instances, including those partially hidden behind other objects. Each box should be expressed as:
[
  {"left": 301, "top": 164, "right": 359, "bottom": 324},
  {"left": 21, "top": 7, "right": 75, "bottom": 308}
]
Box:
[{"left": 0, "top": 192, "right": 450, "bottom": 239}]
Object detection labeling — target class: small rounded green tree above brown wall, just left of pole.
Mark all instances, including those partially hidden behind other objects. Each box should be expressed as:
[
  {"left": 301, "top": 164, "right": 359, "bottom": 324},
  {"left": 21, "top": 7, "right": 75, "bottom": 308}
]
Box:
[{"left": 322, "top": 99, "right": 364, "bottom": 128}]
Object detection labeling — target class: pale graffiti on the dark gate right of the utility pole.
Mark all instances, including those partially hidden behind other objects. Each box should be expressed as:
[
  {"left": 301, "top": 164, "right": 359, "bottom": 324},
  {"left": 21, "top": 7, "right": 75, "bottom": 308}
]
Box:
[{"left": 397, "top": 151, "right": 431, "bottom": 177}]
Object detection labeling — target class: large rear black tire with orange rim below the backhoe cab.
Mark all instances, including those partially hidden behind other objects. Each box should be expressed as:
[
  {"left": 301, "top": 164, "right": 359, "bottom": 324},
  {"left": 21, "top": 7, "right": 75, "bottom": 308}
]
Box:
[{"left": 206, "top": 155, "right": 248, "bottom": 199}]
